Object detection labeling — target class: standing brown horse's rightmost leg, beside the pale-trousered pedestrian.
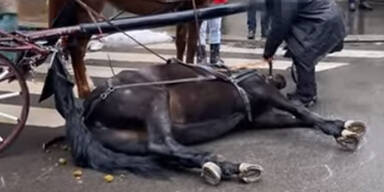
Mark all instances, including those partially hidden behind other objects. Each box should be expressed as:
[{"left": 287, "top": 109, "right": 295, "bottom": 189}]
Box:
[{"left": 186, "top": 22, "right": 201, "bottom": 63}]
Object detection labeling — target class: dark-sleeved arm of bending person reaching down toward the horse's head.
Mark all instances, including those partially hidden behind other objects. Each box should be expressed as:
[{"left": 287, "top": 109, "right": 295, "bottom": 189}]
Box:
[{"left": 263, "top": 0, "right": 298, "bottom": 60}]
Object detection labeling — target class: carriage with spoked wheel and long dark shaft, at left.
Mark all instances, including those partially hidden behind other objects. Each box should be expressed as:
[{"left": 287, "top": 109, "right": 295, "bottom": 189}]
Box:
[{"left": 0, "top": 1, "right": 246, "bottom": 151}]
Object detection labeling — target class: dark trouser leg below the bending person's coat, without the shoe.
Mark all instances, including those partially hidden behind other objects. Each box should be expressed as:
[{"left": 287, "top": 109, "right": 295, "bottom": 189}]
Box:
[{"left": 293, "top": 58, "right": 317, "bottom": 97}]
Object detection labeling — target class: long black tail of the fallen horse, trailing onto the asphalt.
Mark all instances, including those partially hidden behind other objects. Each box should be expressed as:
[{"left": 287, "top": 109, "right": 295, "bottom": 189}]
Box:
[{"left": 41, "top": 54, "right": 162, "bottom": 176}]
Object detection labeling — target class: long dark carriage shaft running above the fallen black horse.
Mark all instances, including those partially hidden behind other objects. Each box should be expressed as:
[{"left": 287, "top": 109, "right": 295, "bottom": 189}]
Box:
[{"left": 28, "top": 3, "right": 248, "bottom": 40}]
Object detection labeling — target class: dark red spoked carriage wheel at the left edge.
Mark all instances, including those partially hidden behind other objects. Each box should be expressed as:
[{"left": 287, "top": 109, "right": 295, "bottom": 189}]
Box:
[{"left": 0, "top": 53, "right": 29, "bottom": 152}]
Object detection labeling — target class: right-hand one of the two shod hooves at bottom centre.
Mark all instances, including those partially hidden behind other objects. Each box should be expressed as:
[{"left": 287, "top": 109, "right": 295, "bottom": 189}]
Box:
[{"left": 239, "top": 163, "right": 263, "bottom": 183}]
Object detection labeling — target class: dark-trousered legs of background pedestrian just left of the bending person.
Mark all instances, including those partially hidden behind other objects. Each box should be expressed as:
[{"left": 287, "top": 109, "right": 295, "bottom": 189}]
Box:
[{"left": 247, "top": 0, "right": 271, "bottom": 39}]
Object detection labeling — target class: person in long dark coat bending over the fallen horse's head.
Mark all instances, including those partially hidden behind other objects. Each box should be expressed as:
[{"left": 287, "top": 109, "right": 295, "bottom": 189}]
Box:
[{"left": 263, "top": 0, "right": 346, "bottom": 107}]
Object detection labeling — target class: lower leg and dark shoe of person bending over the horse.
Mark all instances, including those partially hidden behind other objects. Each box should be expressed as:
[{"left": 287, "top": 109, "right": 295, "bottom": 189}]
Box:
[{"left": 287, "top": 58, "right": 317, "bottom": 107}]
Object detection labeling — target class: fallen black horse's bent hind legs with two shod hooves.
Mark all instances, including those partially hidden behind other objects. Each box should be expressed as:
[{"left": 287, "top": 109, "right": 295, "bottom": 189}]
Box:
[{"left": 146, "top": 91, "right": 262, "bottom": 185}]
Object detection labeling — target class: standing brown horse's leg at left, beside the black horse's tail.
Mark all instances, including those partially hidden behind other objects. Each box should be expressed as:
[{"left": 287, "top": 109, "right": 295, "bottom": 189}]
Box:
[{"left": 69, "top": 37, "right": 91, "bottom": 98}]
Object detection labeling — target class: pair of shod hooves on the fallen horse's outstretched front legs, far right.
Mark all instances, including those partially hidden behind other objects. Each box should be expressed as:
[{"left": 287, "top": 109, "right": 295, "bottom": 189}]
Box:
[{"left": 336, "top": 120, "right": 366, "bottom": 151}]
